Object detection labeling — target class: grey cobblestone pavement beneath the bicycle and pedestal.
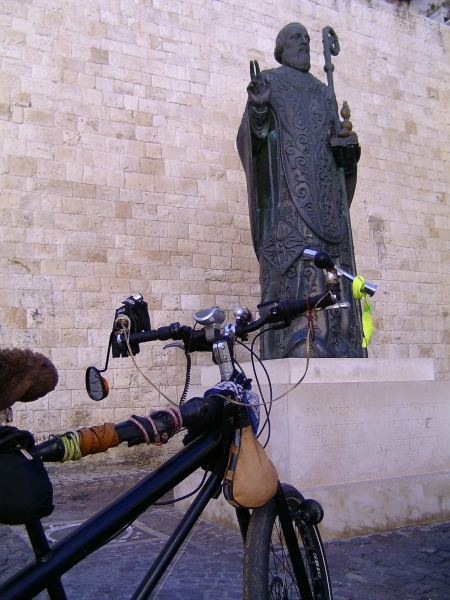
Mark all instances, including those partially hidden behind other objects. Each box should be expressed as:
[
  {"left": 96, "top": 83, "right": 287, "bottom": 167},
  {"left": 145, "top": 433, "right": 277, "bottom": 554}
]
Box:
[{"left": 0, "top": 470, "right": 450, "bottom": 600}]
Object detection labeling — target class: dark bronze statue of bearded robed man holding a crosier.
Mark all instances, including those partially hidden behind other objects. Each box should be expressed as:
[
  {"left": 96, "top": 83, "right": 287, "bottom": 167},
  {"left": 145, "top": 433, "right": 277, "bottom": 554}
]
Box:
[{"left": 237, "top": 23, "right": 365, "bottom": 359}]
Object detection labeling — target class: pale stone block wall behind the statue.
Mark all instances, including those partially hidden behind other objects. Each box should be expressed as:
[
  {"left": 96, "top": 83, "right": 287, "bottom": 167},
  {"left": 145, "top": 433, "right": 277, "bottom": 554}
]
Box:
[{"left": 0, "top": 0, "right": 450, "bottom": 462}]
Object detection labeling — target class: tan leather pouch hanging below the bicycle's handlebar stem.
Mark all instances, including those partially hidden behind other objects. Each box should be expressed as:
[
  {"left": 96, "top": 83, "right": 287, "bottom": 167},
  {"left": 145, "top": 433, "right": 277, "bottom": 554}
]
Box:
[{"left": 223, "top": 426, "right": 278, "bottom": 508}]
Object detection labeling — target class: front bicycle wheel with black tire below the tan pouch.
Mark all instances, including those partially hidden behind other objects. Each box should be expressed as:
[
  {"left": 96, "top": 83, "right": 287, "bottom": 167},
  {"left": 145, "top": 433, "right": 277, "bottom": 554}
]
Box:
[{"left": 243, "top": 484, "right": 332, "bottom": 600}]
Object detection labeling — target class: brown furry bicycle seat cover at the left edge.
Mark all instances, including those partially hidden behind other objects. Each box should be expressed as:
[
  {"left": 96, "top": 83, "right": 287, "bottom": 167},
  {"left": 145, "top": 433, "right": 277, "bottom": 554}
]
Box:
[{"left": 0, "top": 348, "right": 58, "bottom": 410}]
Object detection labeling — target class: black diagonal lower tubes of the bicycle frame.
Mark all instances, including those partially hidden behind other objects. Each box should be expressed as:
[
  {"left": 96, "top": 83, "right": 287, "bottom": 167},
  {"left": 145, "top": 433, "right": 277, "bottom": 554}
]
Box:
[{"left": 0, "top": 429, "right": 224, "bottom": 600}]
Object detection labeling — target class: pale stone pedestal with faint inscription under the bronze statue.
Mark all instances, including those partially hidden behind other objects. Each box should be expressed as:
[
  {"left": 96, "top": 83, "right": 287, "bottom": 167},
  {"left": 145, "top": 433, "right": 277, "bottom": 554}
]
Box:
[{"left": 175, "top": 359, "right": 450, "bottom": 539}]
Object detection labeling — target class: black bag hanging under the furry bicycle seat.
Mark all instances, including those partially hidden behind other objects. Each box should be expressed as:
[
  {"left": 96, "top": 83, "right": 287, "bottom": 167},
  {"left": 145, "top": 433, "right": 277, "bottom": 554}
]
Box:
[{"left": 0, "top": 426, "right": 54, "bottom": 525}]
